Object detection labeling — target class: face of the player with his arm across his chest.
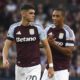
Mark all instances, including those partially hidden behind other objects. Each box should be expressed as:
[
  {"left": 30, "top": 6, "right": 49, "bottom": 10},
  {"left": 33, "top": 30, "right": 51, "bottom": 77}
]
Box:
[{"left": 52, "top": 10, "right": 64, "bottom": 26}]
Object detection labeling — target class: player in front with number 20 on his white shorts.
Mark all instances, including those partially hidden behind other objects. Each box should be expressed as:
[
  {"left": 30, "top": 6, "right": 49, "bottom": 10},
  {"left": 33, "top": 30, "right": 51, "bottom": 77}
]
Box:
[{"left": 3, "top": 4, "right": 54, "bottom": 80}]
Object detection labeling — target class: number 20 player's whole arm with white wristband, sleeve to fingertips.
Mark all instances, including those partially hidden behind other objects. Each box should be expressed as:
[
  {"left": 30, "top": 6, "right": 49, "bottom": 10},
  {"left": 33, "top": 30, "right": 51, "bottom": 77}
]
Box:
[{"left": 38, "top": 27, "right": 54, "bottom": 77}]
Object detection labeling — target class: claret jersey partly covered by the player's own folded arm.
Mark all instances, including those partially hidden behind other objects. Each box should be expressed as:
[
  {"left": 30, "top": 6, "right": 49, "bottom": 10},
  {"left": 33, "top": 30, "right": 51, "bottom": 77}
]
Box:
[{"left": 45, "top": 24, "right": 75, "bottom": 71}]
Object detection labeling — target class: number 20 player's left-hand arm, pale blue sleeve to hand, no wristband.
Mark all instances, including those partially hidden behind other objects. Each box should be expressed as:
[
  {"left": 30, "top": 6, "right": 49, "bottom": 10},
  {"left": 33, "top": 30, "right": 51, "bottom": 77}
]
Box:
[{"left": 2, "top": 25, "right": 15, "bottom": 67}]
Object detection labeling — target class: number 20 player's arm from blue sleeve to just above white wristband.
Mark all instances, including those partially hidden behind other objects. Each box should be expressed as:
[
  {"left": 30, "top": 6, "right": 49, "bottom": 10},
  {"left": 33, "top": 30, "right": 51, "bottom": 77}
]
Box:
[{"left": 38, "top": 27, "right": 53, "bottom": 63}]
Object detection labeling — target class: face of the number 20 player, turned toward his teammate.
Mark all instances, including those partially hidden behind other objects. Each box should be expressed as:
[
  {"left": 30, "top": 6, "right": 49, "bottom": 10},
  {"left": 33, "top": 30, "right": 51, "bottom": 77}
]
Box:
[{"left": 21, "top": 9, "right": 35, "bottom": 22}]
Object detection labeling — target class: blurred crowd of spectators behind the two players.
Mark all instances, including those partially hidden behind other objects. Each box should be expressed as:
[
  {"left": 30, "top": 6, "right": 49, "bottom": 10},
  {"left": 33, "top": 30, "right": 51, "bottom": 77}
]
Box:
[{"left": 0, "top": 0, "right": 80, "bottom": 80}]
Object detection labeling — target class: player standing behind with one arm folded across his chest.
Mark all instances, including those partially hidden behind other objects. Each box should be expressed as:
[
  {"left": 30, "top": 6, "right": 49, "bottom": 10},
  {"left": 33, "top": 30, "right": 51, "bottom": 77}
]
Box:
[{"left": 42, "top": 8, "right": 75, "bottom": 80}]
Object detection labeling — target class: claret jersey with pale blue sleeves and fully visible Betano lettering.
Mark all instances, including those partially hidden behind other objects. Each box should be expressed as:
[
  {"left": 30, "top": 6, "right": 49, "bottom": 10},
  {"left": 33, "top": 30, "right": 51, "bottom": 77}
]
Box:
[{"left": 7, "top": 22, "right": 46, "bottom": 67}]
